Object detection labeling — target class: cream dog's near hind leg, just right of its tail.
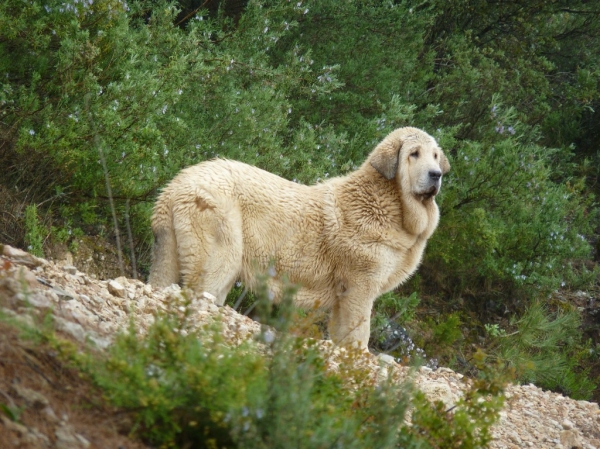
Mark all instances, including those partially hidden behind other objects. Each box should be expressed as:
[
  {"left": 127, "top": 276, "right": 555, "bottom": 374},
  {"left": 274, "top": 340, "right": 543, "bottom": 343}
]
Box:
[{"left": 176, "top": 196, "right": 243, "bottom": 305}]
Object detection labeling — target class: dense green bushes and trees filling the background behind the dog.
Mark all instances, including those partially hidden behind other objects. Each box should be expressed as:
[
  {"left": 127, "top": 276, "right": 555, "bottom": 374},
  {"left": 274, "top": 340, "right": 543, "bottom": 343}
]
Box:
[{"left": 0, "top": 0, "right": 600, "bottom": 396}]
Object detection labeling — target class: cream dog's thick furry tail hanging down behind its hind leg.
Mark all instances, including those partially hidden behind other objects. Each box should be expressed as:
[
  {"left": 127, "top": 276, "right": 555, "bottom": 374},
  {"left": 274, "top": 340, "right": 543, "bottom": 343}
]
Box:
[{"left": 148, "top": 192, "right": 179, "bottom": 288}]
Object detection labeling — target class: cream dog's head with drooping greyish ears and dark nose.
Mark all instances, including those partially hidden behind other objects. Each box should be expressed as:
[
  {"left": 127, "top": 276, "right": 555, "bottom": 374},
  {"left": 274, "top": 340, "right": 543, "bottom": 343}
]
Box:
[{"left": 369, "top": 128, "right": 450, "bottom": 200}]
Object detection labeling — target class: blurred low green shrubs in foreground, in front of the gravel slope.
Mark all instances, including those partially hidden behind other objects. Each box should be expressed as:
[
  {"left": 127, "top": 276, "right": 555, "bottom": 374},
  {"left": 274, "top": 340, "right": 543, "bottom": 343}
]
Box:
[{"left": 10, "top": 291, "right": 505, "bottom": 449}]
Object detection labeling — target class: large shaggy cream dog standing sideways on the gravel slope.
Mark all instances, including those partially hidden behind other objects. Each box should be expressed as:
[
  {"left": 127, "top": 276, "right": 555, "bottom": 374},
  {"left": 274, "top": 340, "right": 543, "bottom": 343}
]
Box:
[{"left": 149, "top": 128, "right": 450, "bottom": 347}]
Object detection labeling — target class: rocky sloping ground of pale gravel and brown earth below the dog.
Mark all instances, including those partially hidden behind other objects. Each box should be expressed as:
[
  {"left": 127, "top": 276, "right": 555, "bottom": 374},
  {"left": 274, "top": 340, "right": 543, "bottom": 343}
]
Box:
[{"left": 0, "top": 245, "right": 600, "bottom": 449}]
